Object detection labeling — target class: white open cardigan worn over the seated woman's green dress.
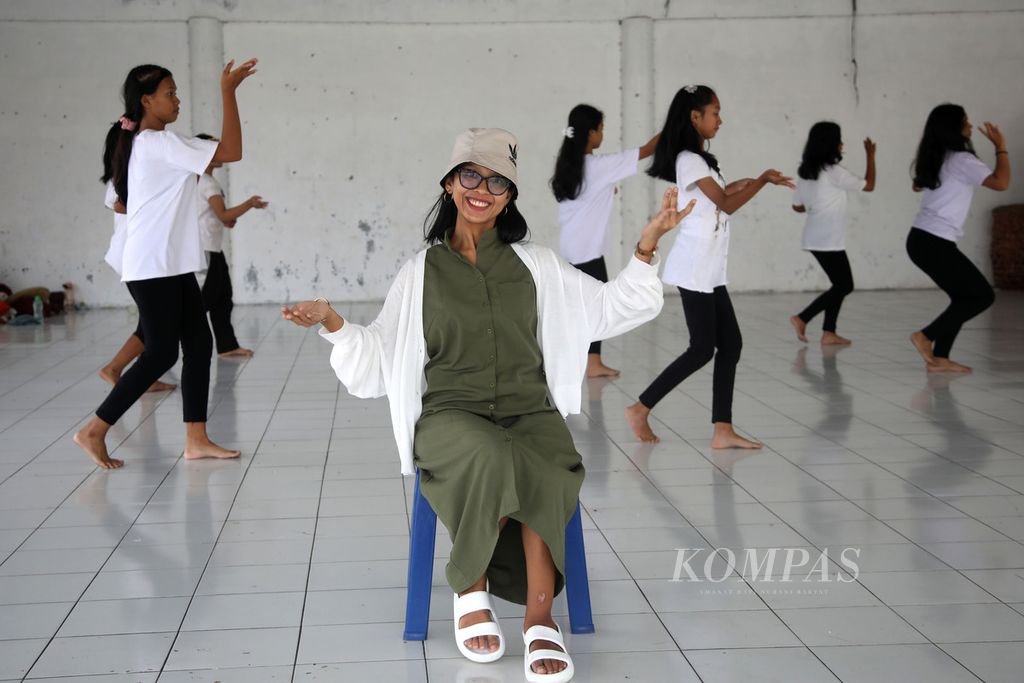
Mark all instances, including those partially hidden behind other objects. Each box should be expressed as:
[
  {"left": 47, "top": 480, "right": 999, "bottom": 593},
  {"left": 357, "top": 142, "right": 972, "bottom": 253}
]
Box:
[{"left": 319, "top": 243, "right": 664, "bottom": 474}]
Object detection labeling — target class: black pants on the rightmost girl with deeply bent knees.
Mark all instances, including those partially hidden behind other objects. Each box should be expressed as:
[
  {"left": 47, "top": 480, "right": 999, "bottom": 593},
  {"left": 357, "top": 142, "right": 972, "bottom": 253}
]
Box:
[{"left": 906, "top": 227, "right": 995, "bottom": 358}]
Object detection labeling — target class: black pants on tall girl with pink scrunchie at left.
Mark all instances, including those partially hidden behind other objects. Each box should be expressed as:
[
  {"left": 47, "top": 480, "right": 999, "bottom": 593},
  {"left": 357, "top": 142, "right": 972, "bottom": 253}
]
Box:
[{"left": 96, "top": 272, "right": 213, "bottom": 425}]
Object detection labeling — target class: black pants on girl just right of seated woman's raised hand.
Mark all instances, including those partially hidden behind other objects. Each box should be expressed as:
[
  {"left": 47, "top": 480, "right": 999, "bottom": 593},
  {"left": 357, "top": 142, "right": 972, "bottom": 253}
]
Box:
[{"left": 640, "top": 285, "right": 743, "bottom": 423}]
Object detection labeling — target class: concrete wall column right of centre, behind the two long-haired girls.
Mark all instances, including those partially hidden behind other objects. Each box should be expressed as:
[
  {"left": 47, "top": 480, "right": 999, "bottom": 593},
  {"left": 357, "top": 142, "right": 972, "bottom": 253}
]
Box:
[{"left": 613, "top": 16, "right": 655, "bottom": 270}]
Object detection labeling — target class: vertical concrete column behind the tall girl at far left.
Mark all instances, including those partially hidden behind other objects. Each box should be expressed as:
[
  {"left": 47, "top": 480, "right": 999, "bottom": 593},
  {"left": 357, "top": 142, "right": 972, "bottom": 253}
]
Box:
[{"left": 190, "top": 16, "right": 231, "bottom": 255}]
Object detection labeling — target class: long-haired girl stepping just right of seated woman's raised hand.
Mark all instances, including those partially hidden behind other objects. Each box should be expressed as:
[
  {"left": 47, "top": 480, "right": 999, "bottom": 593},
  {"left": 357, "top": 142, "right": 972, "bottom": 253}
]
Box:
[{"left": 626, "top": 85, "right": 794, "bottom": 449}]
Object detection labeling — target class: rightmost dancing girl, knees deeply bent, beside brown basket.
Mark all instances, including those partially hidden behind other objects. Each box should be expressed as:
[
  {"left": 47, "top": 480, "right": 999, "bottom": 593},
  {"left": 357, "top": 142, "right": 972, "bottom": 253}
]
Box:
[{"left": 906, "top": 104, "right": 1010, "bottom": 373}]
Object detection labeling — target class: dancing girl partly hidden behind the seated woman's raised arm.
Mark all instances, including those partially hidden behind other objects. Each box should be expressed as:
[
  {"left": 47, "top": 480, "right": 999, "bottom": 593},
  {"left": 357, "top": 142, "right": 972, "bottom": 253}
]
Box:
[{"left": 551, "top": 104, "right": 657, "bottom": 377}]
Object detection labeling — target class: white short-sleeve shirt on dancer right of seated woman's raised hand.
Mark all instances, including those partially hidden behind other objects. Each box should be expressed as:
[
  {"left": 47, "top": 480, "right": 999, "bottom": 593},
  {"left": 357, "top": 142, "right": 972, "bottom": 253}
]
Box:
[{"left": 662, "top": 152, "right": 729, "bottom": 293}]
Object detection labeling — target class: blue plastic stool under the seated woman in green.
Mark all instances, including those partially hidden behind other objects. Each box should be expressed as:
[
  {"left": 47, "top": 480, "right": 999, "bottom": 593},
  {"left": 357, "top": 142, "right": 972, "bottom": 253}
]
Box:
[{"left": 403, "top": 472, "right": 594, "bottom": 640}]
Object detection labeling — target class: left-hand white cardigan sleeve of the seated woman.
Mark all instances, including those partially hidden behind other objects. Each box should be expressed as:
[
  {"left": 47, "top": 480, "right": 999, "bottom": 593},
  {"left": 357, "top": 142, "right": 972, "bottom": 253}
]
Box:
[{"left": 319, "top": 261, "right": 414, "bottom": 398}]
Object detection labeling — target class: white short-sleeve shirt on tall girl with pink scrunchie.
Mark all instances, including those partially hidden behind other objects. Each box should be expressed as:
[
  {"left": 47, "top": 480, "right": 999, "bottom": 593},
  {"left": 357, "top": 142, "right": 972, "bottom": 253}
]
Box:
[{"left": 121, "top": 130, "right": 218, "bottom": 282}]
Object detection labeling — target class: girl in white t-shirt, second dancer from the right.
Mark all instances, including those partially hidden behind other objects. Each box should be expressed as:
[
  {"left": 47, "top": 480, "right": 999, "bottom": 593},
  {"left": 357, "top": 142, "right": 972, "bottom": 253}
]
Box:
[{"left": 790, "top": 121, "right": 874, "bottom": 346}]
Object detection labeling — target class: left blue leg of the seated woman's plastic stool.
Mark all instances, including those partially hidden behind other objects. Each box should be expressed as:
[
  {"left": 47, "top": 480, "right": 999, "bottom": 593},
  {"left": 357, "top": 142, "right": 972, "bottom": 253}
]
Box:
[{"left": 402, "top": 472, "right": 437, "bottom": 640}]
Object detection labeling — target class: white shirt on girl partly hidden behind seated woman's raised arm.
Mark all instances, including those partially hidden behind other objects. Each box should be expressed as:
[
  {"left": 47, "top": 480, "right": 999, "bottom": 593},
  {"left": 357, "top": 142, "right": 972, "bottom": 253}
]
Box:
[{"left": 558, "top": 150, "right": 640, "bottom": 263}]
